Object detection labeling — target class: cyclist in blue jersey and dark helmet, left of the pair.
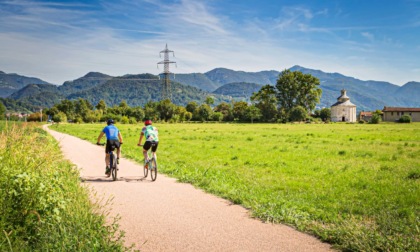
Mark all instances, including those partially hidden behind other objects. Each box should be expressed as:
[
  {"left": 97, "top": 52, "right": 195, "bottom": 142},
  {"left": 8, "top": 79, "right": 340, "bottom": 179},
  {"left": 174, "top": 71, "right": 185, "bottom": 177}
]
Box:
[{"left": 96, "top": 119, "right": 122, "bottom": 177}]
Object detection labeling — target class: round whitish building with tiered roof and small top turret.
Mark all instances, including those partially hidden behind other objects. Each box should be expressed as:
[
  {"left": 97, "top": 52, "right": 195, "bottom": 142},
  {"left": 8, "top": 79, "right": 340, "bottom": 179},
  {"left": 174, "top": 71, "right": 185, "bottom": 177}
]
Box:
[{"left": 331, "top": 89, "right": 356, "bottom": 122}]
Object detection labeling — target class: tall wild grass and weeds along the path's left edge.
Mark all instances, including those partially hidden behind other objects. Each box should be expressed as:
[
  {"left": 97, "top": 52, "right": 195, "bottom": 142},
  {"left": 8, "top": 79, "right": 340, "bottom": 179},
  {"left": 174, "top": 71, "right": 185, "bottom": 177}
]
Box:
[{"left": 0, "top": 122, "right": 131, "bottom": 251}]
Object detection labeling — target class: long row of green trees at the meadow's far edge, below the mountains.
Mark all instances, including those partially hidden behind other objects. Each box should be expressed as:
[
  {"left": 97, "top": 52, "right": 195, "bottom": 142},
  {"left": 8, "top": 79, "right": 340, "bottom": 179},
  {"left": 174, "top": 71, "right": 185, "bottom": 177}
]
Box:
[{"left": 2, "top": 70, "right": 331, "bottom": 123}]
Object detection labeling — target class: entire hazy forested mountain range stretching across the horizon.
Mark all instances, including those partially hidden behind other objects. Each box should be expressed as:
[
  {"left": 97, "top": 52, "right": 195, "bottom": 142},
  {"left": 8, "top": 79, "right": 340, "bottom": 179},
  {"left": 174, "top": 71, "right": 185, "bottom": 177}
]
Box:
[{"left": 0, "top": 66, "right": 420, "bottom": 111}]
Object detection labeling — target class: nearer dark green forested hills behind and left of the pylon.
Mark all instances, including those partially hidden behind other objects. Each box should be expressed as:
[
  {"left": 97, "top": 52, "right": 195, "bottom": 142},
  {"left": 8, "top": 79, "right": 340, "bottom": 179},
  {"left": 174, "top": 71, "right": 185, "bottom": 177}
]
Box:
[{"left": 2, "top": 72, "right": 231, "bottom": 112}]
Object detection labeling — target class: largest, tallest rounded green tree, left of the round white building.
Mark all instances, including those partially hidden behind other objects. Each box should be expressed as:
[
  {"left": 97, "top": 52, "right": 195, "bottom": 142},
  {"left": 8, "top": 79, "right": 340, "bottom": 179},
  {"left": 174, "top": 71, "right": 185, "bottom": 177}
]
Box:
[{"left": 276, "top": 70, "right": 322, "bottom": 118}]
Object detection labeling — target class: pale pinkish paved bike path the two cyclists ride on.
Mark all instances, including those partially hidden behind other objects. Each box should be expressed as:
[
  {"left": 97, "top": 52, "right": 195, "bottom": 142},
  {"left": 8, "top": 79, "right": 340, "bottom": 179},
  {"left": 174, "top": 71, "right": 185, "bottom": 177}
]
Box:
[{"left": 45, "top": 127, "right": 331, "bottom": 252}]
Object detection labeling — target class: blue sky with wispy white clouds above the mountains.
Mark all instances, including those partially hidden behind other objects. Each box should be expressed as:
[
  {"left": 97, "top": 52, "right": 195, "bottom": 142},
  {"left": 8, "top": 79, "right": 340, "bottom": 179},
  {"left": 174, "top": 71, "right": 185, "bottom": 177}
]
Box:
[{"left": 0, "top": 0, "right": 420, "bottom": 85}]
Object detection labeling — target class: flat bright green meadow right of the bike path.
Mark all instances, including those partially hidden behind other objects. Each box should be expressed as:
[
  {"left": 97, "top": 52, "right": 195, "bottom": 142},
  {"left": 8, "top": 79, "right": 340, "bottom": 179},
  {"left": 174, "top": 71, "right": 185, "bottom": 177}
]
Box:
[{"left": 51, "top": 123, "right": 420, "bottom": 251}]
